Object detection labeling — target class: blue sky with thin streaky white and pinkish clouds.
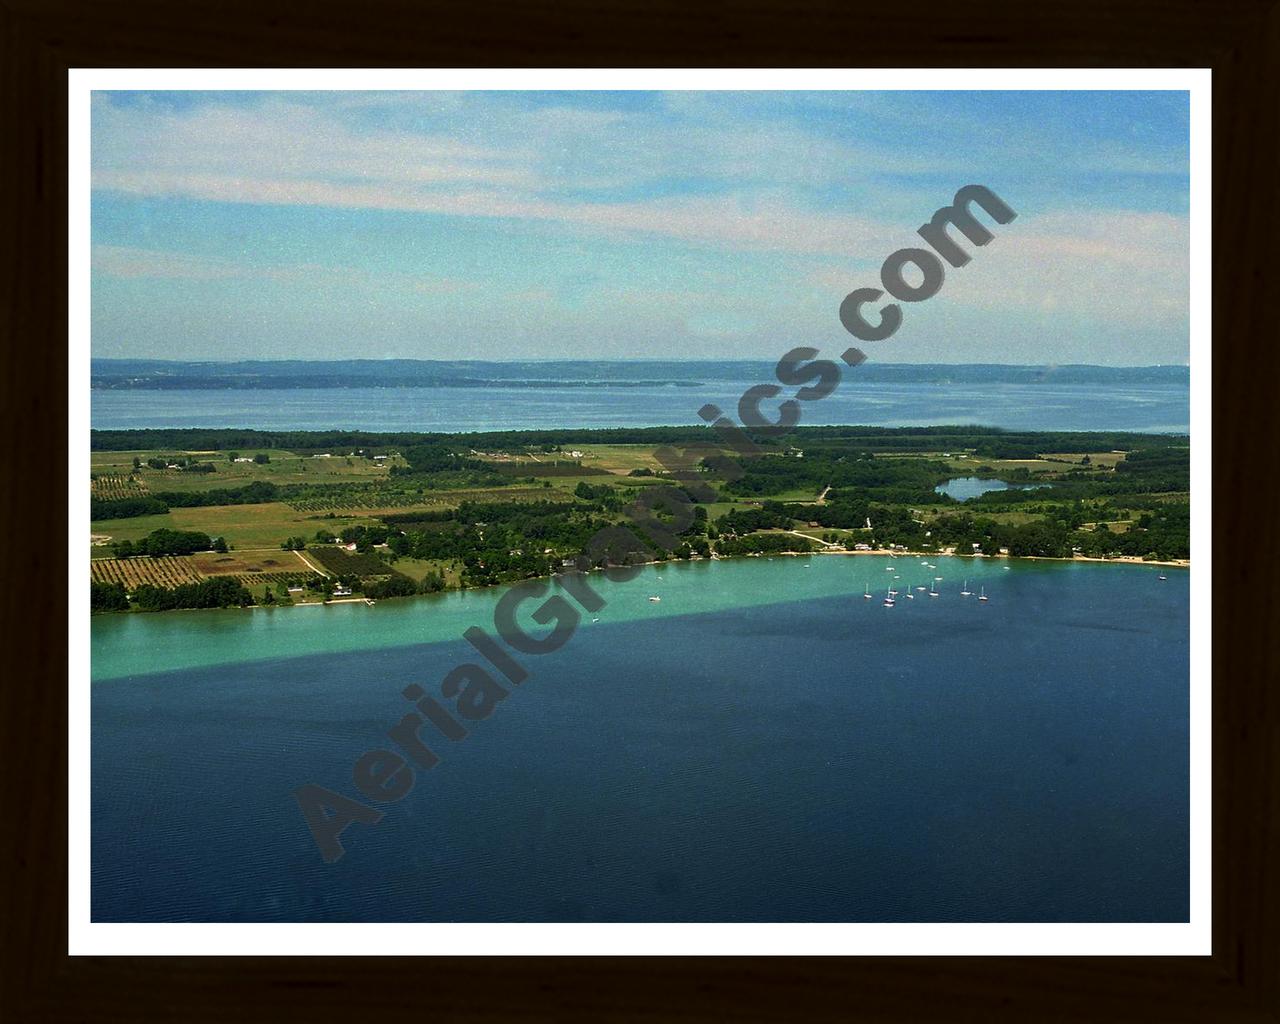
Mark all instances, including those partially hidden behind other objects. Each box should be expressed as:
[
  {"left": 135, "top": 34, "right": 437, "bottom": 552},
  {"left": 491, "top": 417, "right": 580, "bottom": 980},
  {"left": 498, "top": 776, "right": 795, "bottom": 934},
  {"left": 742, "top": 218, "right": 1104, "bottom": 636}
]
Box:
[{"left": 91, "top": 91, "right": 1189, "bottom": 366}]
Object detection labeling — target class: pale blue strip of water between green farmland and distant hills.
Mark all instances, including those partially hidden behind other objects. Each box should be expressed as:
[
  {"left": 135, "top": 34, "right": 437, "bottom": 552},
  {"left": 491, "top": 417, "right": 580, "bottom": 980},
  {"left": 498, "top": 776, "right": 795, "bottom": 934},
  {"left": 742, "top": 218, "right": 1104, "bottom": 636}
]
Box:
[{"left": 92, "top": 378, "right": 1190, "bottom": 434}]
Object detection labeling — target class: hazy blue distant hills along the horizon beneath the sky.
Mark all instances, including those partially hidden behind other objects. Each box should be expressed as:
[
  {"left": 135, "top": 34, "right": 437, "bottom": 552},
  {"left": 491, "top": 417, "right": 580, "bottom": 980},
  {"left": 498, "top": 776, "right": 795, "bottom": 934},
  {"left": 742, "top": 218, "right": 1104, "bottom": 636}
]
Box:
[{"left": 91, "top": 360, "right": 1190, "bottom": 390}]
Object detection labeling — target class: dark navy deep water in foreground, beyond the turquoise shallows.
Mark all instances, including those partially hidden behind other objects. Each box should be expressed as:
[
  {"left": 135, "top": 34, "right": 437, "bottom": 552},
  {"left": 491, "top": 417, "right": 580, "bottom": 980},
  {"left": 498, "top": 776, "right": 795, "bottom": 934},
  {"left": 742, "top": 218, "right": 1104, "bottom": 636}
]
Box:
[{"left": 92, "top": 558, "right": 1189, "bottom": 922}]
